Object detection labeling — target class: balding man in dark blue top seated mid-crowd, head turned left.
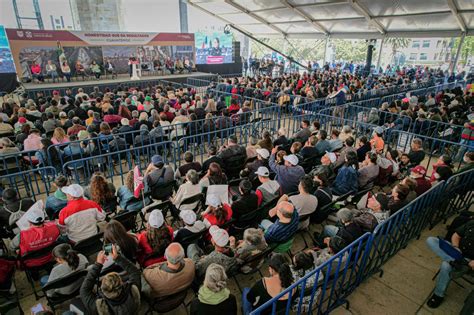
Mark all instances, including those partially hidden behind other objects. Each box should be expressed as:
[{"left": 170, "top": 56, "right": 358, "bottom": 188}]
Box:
[{"left": 261, "top": 201, "right": 299, "bottom": 244}]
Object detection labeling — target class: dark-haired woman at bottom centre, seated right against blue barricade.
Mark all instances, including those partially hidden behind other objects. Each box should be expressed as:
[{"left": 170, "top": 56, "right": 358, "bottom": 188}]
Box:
[{"left": 242, "top": 254, "right": 295, "bottom": 315}]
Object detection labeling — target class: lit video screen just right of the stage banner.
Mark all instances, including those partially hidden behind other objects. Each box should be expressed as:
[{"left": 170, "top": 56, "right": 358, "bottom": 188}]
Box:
[{"left": 194, "top": 32, "right": 234, "bottom": 65}]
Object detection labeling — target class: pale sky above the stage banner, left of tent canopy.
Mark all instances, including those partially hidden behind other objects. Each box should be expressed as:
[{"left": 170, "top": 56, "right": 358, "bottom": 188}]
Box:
[{"left": 0, "top": 0, "right": 225, "bottom": 33}]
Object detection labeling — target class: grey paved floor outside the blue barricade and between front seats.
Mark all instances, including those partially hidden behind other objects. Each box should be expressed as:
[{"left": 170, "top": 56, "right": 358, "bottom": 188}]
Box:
[{"left": 11, "top": 216, "right": 473, "bottom": 315}]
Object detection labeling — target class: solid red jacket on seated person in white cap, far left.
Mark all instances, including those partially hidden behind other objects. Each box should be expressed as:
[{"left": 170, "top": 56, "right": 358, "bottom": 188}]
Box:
[{"left": 20, "top": 222, "right": 60, "bottom": 267}]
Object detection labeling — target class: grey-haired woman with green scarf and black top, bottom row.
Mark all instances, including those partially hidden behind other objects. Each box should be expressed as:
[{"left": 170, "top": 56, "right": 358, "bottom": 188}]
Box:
[{"left": 191, "top": 263, "right": 237, "bottom": 314}]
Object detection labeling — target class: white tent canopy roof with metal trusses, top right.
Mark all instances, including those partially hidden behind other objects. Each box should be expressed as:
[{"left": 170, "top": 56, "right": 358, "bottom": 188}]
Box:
[{"left": 188, "top": 0, "right": 474, "bottom": 39}]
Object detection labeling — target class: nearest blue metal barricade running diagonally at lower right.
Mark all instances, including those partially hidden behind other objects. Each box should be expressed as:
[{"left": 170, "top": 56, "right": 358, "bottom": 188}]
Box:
[{"left": 250, "top": 170, "right": 474, "bottom": 315}]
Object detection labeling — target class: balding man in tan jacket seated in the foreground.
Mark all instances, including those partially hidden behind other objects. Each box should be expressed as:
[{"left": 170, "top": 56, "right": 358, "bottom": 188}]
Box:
[{"left": 142, "top": 243, "right": 195, "bottom": 298}]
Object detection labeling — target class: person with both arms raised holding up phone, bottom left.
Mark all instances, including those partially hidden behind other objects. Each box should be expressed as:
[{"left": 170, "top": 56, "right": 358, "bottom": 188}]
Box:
[{"left": 80, "top": 245, "right": 141, "bottom": 314}]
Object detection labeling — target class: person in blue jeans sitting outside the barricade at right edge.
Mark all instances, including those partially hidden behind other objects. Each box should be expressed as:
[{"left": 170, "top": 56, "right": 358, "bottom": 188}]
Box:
[{"left": 426, "top": 220, "right": 474, "bottom": 308}]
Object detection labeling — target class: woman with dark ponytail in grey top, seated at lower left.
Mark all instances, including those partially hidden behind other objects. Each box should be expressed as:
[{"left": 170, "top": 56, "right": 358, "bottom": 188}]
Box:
[{"left": 40, "top": 244, "right": 89, "bottom": 296}]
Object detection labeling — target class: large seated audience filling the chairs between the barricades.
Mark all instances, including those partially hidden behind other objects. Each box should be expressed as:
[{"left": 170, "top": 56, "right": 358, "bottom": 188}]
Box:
[{"left": 0, "top": 69, "right": 474, "bottom": 314}]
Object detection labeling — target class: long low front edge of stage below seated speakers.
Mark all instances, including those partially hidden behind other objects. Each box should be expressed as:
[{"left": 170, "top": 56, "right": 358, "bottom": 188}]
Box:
[{"left": 23, "top": 72, "right": 216, "bottom": 98}]
